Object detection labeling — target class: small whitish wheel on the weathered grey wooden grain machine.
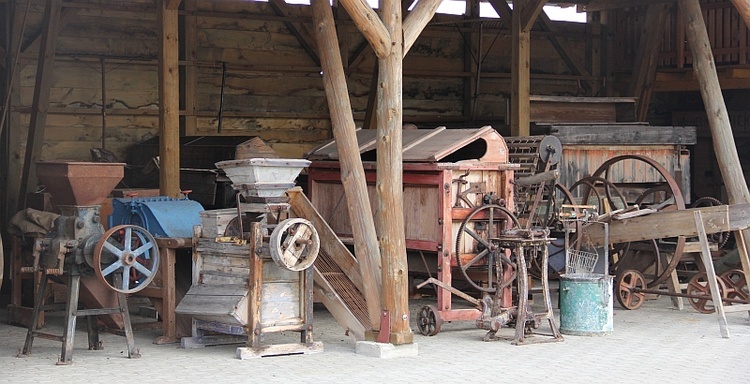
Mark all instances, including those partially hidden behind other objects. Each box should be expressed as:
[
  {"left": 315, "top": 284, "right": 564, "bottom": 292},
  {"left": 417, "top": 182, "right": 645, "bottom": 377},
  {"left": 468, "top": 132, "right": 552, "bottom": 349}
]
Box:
[{"left": 268, "top": 218, "right": 320, "bottom": 272}]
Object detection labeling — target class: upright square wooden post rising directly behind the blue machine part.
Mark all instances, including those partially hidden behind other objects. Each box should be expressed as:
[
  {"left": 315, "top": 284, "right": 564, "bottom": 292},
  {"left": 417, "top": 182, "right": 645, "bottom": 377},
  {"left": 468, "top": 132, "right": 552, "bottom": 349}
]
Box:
[{"left": 158, "top": 0, "right": 180, "bottom": 197}]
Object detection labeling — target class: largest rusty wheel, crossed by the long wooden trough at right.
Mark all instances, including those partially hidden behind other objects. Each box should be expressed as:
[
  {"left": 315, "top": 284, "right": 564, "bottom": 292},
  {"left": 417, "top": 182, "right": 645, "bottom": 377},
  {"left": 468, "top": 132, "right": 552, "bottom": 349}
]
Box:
[{"left": 592, "top": 155, "right": 685, "bottom": 288}]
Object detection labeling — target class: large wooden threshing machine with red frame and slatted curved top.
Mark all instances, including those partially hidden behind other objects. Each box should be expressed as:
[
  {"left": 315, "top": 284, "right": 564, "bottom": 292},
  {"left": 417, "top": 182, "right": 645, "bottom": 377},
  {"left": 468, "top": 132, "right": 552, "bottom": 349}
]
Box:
[{"left": 307, "top": 126, "right": 519, "bottom": 334}]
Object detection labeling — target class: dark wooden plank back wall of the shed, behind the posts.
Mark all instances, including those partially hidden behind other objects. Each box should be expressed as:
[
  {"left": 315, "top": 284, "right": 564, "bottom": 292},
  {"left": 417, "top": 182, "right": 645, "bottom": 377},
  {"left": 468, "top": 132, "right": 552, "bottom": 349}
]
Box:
[{"left": 0, "top": 0, "right": 587, "bottom": 167}]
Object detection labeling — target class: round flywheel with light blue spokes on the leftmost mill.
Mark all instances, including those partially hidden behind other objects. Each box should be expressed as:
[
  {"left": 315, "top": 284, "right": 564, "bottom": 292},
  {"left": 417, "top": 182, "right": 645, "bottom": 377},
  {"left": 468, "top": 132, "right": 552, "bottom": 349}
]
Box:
[{"left": 92, "top": 224, "right": 159, "bottom": 293}]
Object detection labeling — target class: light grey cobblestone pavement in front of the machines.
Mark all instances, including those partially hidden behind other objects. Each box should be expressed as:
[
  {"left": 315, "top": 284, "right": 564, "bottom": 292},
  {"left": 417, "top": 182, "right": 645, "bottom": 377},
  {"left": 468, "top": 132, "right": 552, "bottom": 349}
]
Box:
[{"left": 0, "top": 297, "right": 750, "bottom": 384}]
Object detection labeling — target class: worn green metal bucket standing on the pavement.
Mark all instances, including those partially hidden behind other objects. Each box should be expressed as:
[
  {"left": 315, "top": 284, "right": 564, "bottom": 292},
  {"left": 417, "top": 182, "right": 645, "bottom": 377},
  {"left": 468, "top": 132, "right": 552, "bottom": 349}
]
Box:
[{"left": 560, "top": 273, "right": 613, "bottom": 336}]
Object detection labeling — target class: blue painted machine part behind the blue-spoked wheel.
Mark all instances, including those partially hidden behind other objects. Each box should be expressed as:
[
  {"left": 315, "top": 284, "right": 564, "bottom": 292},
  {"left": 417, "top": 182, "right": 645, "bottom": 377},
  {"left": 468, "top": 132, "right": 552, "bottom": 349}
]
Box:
[{"left": 109, "top": 196, "right": 203, "bottom": 238}]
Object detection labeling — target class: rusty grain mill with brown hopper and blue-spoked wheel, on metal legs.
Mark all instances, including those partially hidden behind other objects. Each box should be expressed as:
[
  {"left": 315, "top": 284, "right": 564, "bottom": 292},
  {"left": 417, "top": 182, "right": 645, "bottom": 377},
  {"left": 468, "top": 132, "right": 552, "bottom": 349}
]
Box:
[{"left": 22, "top": 161, "right": 159, "bottom": 364}]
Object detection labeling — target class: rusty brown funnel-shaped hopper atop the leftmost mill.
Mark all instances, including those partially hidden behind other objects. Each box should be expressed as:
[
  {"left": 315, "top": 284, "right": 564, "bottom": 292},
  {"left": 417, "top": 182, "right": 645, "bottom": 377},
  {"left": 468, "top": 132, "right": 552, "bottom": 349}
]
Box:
[{"left": 36, "top": 161, "right": 125, "bottom": 206}]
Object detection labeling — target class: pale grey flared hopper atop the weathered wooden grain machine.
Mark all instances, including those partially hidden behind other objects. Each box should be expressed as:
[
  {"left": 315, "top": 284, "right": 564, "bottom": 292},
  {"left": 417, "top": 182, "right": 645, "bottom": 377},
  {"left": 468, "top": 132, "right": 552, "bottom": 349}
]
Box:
[{"left": 216, "top": 158, "right": 310, "bottom": 197}]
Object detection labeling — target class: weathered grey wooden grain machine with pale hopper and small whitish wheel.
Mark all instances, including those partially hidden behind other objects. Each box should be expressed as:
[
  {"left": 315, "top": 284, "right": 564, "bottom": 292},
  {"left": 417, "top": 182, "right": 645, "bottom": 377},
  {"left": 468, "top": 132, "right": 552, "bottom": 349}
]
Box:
[{"left": 175, "top": 158, "right": 322, "bottom": 359}]
